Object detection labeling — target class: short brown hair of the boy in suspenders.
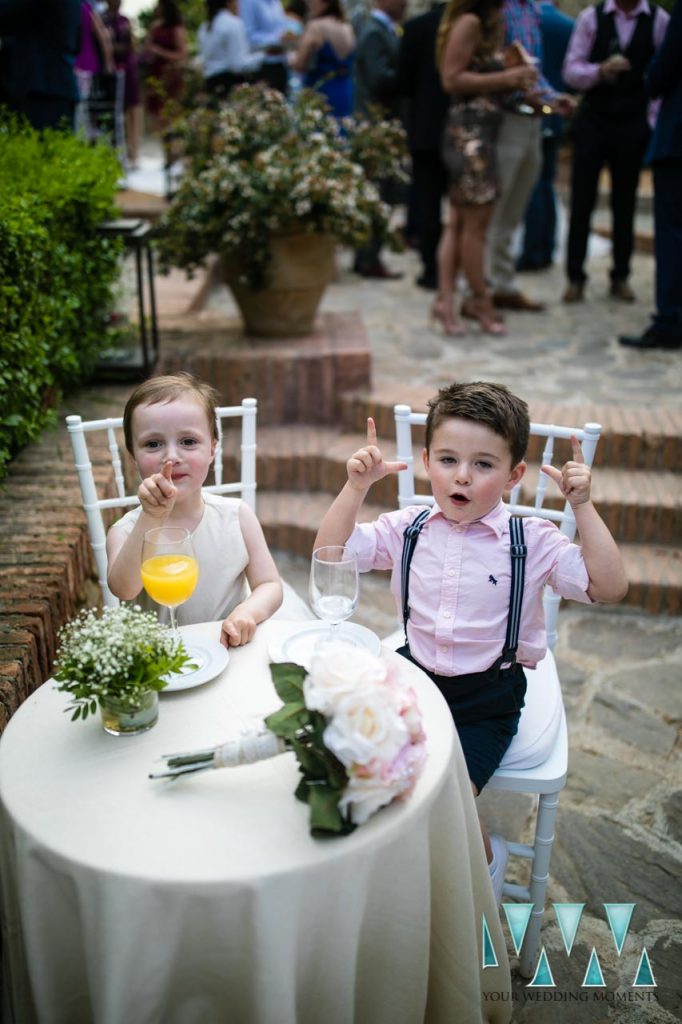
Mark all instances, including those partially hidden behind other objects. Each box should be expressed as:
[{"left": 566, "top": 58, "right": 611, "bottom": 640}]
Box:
[{"left": 426, "top": 381, "right": 530, "bottom": 466}]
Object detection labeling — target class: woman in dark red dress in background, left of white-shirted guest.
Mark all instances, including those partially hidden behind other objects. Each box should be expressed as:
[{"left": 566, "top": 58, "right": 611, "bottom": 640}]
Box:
[{"left": 142, "top": 0, "right": 187, "bottom": 132}]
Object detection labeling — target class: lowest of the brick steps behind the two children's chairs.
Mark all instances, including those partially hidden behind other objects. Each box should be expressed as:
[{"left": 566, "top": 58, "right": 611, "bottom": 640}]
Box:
[{"left": 258, "top": 492, "right": 682, "bottom": 615}]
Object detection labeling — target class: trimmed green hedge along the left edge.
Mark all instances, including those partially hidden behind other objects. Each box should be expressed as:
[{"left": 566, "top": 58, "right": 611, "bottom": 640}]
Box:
[{"left": 0, "top": 112, "right": 120, "bottom": 478}]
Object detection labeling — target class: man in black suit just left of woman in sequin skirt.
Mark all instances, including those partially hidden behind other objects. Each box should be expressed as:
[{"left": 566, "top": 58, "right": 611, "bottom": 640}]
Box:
[{"left": 397, "top": 3, "right": 447, "bottom": 289}]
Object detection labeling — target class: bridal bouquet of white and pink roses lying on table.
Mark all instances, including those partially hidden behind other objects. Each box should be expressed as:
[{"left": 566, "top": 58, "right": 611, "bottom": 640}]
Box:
[{"left": 152, "top": 642, "right": 426, "bottom": 836}]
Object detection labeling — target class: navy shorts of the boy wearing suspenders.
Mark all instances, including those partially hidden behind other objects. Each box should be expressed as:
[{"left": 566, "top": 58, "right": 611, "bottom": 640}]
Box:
[{"left": 398, "top": 644, "right": 525, "bottom": 793}]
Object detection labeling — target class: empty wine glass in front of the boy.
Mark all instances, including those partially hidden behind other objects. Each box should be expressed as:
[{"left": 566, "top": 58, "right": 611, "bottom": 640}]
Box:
[{"left": 309, "top": 544, "right": 359, "bottom": 644}]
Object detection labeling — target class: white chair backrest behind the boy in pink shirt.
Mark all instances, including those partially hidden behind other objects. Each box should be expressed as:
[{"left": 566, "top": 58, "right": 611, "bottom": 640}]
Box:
[{"left": 393, "top": 406, "right": 601, "bottom": 650}]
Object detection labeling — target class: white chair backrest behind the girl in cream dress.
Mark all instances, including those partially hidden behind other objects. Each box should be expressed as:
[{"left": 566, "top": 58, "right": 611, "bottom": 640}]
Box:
[{"left": 67, "top": 398, "right": 257, "bottom": 607}]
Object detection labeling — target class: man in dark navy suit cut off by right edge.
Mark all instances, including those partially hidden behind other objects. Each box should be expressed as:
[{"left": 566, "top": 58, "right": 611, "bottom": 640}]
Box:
[{"left": 620, "top": 0, "right": 682, "bottom": 348}]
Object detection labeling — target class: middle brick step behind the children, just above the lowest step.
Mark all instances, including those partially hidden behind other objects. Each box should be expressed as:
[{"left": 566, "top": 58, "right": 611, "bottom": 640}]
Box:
[{"left": 223, "top": 425, "right": 682, "bottom": 544}]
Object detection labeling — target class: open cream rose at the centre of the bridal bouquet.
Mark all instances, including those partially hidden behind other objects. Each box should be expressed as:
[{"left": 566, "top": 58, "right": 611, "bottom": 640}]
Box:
[{"left": 324, "top": 683, "right": 410, "bottom": 768}]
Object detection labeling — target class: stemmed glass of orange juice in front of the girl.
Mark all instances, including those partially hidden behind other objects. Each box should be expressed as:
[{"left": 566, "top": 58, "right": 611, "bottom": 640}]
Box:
[{"left": 140, "top": 526, "right": 199, "bottom": 638}]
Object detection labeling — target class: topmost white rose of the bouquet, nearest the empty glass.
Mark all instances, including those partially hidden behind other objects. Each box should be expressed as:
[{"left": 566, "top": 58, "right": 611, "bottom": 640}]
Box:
[{"left": 303, "top": 641, "right": 386, "bottom": 715}]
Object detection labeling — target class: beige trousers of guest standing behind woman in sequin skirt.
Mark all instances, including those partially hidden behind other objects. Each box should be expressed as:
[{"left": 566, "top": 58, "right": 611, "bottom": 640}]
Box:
[{"left": 485, "top": 112, "right": 542, "bottom": 293}]
